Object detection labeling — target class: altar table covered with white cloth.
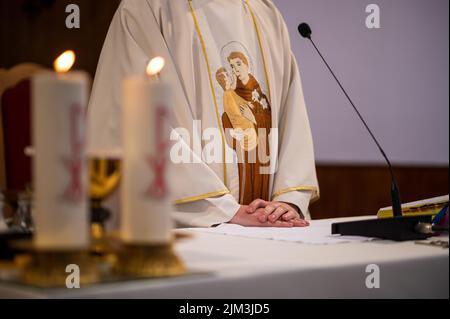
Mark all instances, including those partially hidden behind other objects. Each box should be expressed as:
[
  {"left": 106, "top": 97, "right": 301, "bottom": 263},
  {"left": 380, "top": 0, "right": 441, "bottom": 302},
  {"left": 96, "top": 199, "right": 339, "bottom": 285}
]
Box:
[{"left": 0, "top": 218, "right": 449, "bottom": 299}]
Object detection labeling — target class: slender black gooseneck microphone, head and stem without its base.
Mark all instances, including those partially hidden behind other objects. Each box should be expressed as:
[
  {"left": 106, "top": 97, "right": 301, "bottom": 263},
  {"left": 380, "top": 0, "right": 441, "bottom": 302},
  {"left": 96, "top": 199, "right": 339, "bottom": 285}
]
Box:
[{"left": 298, "top": 23, "right": 402, "bottom": 217}]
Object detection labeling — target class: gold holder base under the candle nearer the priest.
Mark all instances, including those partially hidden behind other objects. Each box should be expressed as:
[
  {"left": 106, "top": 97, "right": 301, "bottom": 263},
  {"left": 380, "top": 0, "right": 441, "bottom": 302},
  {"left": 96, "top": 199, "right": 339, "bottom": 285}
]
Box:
[{"left": 113, "top": 244, "right": 186, "bottom": 278}]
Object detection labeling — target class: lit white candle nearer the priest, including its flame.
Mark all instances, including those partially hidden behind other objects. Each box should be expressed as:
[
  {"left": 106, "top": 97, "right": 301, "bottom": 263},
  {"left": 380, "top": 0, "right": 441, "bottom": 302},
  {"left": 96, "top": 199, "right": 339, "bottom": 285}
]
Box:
[{"left": 121, "top": 59, "right": 172, "bottom": 244}]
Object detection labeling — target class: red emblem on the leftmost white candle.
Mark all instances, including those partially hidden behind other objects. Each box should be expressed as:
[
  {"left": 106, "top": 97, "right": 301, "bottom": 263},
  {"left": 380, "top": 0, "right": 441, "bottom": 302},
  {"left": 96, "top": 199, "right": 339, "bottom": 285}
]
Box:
[{"left": 63, "top": 104, "right": 84, "bottom": 202}]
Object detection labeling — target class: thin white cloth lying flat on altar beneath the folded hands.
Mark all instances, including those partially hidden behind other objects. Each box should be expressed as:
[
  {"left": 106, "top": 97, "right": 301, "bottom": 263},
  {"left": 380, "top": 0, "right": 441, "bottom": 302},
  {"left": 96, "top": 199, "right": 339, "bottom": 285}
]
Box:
[{"left": 185, "top": 220, "right": 373, "bottom": 245}]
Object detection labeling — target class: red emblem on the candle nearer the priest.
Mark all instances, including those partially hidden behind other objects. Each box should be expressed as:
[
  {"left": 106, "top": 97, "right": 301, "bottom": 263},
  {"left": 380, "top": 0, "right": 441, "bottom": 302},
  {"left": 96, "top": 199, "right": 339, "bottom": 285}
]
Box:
[{"left": 146, "top": 106, "right": 169, "bottom": 198}]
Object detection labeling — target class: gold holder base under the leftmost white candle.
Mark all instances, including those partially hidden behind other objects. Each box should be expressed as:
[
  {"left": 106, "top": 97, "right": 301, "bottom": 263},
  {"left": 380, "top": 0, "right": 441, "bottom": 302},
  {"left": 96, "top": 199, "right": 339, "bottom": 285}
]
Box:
[{"left": 21, "top": 250, "right": 100, "bottom": 288}]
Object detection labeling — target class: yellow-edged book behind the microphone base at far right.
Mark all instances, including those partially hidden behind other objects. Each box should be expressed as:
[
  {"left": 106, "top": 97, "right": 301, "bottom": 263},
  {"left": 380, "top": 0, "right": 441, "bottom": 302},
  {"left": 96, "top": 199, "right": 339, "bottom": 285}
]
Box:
[{"left": 377, "top": 195, "right": 448, "bottom": 218}]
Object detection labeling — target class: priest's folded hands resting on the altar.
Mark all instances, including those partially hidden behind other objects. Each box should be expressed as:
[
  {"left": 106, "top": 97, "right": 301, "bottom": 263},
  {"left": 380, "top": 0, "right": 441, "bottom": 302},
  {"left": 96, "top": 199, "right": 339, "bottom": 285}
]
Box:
[{"left": 229, "top": 199, "right": 309, "bottom": 227}]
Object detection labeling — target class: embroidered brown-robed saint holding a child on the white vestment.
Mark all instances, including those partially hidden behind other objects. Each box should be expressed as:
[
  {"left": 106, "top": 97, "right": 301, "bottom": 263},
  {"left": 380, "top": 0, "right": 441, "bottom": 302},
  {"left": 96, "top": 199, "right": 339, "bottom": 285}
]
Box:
[{"left": 216, "top": 44, "right": 272, "bottom": 205}]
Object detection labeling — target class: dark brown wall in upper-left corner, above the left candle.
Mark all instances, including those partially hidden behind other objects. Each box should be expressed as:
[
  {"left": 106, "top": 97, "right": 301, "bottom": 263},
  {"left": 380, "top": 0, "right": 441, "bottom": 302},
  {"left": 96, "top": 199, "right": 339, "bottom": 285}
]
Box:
[{"left": 0, "top": 0, "right": 120, "bottom": 75}]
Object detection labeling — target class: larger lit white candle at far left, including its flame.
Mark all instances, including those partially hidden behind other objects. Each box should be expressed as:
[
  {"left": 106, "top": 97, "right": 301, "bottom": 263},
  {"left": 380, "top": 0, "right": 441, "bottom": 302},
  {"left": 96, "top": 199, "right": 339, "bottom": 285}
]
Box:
[{"left": 32, "top": 52, "right": 89, "bottom": 250}]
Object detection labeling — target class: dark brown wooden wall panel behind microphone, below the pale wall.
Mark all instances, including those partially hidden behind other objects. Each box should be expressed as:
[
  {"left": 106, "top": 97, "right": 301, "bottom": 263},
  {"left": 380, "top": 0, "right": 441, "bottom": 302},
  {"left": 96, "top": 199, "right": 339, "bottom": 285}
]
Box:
[{"left": 311, "top": 165, "right": 449, "bottom": 219}]
